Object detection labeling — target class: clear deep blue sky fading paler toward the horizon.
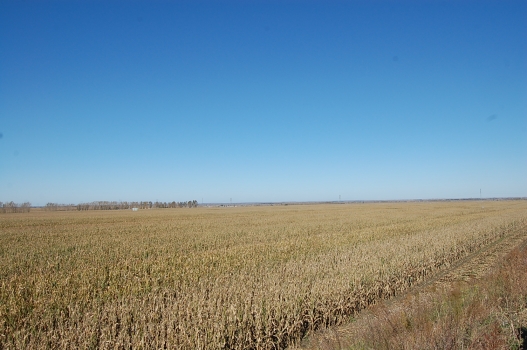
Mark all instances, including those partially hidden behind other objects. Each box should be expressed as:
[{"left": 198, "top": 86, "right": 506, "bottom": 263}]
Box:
[{"left": 0, "top": 0, "right": 527, "bottom": 205}]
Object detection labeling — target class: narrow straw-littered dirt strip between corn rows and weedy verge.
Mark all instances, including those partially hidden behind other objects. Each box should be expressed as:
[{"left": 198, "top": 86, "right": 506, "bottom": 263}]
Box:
[{"left": 291, "top": 223, "right": 527, "bottom": 350}]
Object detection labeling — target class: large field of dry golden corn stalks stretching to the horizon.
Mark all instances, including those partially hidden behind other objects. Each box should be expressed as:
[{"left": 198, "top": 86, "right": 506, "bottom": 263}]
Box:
[{"left": 0, "top": 200, "right": 527, "bottom": 349}]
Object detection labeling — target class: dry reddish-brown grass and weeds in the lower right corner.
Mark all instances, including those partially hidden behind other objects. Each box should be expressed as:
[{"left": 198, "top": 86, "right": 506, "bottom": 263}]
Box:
[{"left": 296, "top": 241, "right": 527, "bottom": 350}]
